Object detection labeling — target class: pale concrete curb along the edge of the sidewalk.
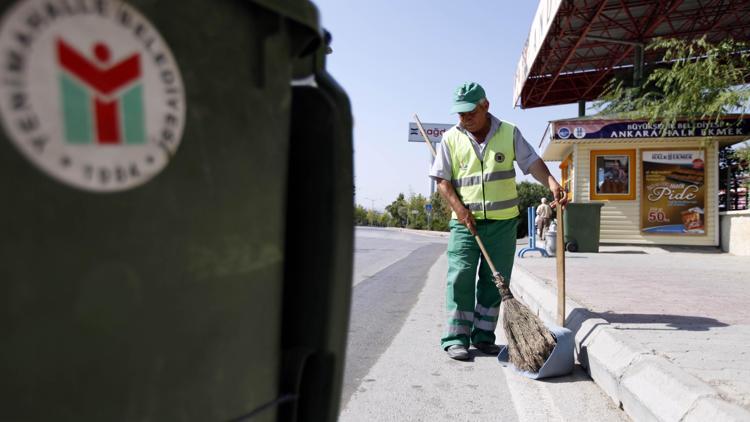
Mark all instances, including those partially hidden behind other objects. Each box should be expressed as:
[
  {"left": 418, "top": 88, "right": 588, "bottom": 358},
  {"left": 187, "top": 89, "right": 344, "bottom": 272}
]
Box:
[{"left": 511, "top": 265, "right": 750, "bottom": 422}]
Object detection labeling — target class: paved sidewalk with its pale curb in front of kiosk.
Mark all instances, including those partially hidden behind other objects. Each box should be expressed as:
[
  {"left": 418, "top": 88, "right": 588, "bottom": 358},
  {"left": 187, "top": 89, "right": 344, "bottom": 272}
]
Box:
[{"left": 512, "top": 243, "right": 750, "bottom": 421}]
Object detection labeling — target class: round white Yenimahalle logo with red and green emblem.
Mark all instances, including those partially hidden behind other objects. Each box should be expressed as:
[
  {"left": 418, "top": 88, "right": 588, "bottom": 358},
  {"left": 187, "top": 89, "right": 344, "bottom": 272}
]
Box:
[{"left": 0, "top": 0, "right": 186, "bottom": 192}]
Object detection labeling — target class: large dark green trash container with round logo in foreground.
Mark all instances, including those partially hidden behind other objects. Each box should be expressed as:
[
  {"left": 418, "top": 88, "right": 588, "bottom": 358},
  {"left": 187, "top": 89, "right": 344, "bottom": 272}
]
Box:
[{"left": 0, "top": 0, "right": 353, "bottom": 421}]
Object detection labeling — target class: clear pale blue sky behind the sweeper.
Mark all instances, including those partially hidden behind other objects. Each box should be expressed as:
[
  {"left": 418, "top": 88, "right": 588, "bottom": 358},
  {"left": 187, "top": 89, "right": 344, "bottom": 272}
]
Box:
[{"left": 313, "top": 0, "right": 578, "bottom": 210}]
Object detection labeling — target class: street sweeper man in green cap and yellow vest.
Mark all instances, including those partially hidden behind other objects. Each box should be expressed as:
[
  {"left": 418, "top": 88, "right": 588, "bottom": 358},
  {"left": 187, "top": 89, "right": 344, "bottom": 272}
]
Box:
[{"left": 430, "top": 82, "right": 562, "bottom": 360}]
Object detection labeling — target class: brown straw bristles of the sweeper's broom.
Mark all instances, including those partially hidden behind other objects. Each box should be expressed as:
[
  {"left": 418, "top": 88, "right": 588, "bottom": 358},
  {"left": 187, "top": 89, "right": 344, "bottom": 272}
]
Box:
[{"left": 502, "top": 296, "right": 556, "bottom": 372}]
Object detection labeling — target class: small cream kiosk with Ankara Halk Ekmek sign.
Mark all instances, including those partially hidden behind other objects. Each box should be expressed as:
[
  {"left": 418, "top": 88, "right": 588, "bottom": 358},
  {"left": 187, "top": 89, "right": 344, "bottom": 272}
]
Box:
[{"left": 540, "top": 115, "right": 750, "bottom": 246}]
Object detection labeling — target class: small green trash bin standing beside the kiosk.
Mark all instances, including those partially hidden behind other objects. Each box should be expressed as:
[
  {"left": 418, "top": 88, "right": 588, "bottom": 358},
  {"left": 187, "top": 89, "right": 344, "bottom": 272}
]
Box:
[{"left": 564, "top": 202, "right": 604, "bottom": 252}]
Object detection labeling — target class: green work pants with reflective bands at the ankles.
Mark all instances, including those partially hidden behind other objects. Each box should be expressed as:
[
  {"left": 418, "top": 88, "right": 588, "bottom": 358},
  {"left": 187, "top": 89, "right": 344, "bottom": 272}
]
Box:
[{"left": 441, "top": 218, "right": 518, "bottom": 349}]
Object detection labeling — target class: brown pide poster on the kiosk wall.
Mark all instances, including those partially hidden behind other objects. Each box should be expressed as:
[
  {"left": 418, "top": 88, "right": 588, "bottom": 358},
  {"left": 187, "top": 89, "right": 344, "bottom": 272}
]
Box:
[{"left": 641, "top": 150, "right": 706, "bottom": 235}]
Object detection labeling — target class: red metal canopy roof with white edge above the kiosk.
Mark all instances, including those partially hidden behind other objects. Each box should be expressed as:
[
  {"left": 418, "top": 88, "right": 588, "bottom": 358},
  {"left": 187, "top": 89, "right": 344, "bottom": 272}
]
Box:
[{"left": 513, "top": 0, "right": 750, "bottom": 108}]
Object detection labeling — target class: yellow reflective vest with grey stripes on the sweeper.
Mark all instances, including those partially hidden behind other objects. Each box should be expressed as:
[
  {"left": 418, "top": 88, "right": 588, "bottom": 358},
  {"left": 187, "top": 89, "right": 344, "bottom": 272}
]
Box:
[{"left": 443, "top": 121, "right": 519, "bottom": 220}]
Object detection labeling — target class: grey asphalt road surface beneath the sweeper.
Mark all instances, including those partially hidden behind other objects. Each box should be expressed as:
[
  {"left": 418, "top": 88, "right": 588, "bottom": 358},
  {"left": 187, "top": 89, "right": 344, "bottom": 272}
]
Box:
[{"left": 340, "top": 227, "right": 628, "bottom": 422}]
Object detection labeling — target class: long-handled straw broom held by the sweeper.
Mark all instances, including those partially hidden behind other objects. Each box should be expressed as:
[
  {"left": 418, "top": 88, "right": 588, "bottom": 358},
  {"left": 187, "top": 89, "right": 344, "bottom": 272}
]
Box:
[{"left": 414, "top": 114, "right": 556, "bottom": 372}]
